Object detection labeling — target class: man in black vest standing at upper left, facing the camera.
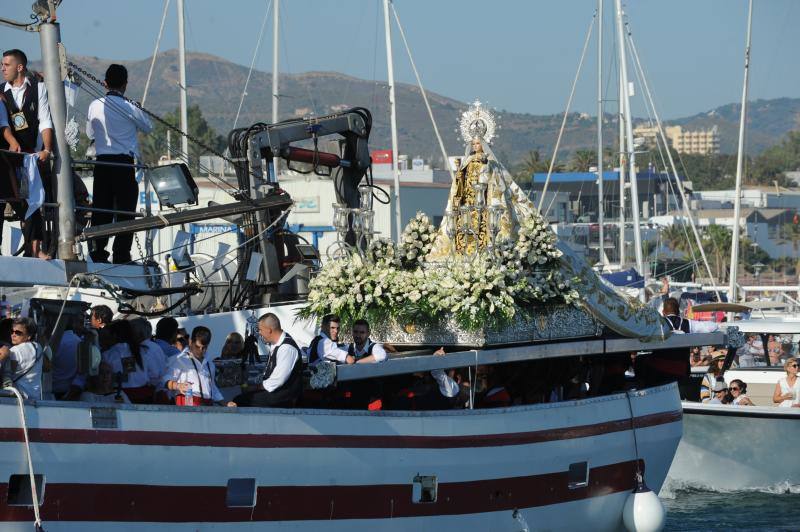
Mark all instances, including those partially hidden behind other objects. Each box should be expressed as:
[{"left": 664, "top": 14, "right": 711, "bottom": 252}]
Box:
[{"left": 0, "top": 49, "right": 54, "bottom": 258}]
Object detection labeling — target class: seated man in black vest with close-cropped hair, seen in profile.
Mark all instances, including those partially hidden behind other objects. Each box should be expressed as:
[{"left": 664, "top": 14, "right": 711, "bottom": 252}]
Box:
[{"left": 233, "top": 312, "right": 303, "bottom": 407}]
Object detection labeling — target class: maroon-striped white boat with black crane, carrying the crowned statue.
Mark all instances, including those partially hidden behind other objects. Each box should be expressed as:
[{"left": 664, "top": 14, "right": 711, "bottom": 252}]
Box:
[{"left": 0, "top": 2, "right": 739, "bottom": 531}]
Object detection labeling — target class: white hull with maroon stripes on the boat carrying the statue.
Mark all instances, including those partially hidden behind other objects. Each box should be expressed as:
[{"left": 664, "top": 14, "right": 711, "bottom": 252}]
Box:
[{"left": 0, "top": 385, "right": 682, "bottom": 532}]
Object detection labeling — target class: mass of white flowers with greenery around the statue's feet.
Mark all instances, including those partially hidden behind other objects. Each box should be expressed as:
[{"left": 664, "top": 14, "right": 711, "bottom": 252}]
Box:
[{"left": 301, "top": 213, "right": 579, "bottom": 330}]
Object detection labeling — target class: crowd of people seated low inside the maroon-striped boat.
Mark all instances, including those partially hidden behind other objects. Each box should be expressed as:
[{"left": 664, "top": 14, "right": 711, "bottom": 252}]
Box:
[{"left": 0, "top": 305, "right": 656, "bottom": 410}]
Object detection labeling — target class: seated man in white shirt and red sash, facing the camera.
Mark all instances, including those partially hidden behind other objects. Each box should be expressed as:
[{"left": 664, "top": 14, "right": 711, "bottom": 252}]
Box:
[{"left": 164, "top": 325, "right": 223, "bottom": 406}]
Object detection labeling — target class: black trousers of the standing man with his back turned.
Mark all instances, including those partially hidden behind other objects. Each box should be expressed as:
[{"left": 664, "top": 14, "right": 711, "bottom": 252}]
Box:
[{"left": 90, "top": 155, "right": 139, "bottom": 264}]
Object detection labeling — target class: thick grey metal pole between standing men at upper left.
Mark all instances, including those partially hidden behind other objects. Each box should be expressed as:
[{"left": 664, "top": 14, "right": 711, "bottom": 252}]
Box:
[{"left": 39, "top": 22, "right": 77, "bottom": 260}]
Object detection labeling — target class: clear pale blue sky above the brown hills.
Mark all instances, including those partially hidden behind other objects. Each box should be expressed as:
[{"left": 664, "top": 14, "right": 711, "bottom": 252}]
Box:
[{"left": 0, "top": 0, "right": 800, "bottom": 119}]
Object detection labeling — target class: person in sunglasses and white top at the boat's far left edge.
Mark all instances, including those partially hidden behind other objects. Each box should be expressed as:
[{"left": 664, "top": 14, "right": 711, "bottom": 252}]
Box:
[{"left": 0, "top": 318, "right": 43, "bottom": 399}]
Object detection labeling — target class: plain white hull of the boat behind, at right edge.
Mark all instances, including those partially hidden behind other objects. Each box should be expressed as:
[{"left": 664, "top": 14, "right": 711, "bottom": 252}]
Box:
[{"left": 669, "top": 403, "right": 800, "bottom": 490}]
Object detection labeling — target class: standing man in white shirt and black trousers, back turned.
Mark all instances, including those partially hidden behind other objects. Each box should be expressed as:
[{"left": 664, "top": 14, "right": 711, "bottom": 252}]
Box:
[{"left": 86, "top": 65, "right": 153, "bottom": 264}]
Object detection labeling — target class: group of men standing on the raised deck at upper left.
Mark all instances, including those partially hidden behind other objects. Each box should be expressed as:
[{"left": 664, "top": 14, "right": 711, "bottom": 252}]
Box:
[{"left": 0, "top": 49, "right": 153, "bottom": 264}]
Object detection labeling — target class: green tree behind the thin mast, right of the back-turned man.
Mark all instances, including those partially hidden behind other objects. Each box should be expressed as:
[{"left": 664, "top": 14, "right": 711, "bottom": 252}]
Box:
[{"left": 139, "top": 105, "right": 226, "bottom": 174}]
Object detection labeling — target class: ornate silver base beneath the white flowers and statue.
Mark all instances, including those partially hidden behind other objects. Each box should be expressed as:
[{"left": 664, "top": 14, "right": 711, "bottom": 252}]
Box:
[{"left": 370, "top": 305, "right": 603, "bottom": 347}]
